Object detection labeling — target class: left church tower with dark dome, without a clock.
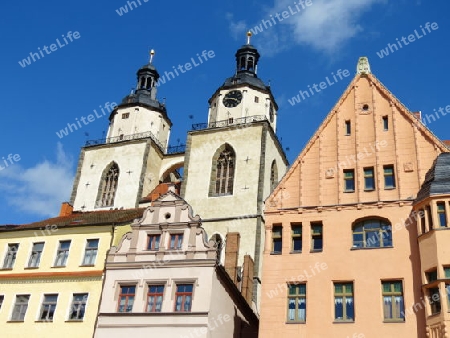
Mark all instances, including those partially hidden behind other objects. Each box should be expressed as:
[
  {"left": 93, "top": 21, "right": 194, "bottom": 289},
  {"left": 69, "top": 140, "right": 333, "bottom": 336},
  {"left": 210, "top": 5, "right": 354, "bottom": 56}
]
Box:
[{"left": 70, "top": 50, "right": 172, "bottom": 211}]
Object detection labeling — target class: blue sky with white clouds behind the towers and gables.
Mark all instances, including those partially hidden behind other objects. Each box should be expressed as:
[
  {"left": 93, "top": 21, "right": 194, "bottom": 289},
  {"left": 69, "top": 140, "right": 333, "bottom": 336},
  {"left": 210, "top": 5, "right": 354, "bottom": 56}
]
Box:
[{"left": 0, "top": 0, "right": 450, "bottom": 224}]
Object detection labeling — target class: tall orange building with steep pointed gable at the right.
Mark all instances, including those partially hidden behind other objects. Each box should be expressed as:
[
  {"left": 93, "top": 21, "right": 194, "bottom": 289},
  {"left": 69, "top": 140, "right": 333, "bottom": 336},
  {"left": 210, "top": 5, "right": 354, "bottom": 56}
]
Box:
[{"left": 259, "top": 57, "right": 450, "bottom": 338}]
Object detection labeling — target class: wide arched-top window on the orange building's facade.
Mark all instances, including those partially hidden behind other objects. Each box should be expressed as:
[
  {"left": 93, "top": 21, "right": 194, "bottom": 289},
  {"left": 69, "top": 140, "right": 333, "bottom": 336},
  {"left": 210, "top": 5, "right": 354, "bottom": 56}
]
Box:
[{"left": 353, "top": 219, "right": 392, "bottom": 248}]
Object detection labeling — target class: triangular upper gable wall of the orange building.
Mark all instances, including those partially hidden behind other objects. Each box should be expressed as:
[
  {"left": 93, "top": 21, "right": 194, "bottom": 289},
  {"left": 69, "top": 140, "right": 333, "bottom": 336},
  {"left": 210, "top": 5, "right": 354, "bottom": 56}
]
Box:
[{"left": 266, "top": 68, "right": 449, "bottom": 212}]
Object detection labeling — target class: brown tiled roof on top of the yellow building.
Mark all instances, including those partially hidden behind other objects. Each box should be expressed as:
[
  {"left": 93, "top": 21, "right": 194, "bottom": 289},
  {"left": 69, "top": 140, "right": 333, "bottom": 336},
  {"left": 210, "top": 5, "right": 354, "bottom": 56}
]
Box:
[{"left": 0, "top": 208, "right": 145, "bottom": 231}]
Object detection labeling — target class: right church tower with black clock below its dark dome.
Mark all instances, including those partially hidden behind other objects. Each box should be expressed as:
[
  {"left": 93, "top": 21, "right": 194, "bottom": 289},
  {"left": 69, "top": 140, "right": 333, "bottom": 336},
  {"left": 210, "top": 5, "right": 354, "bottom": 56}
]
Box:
[{"left": 181, "top": 33, "right": 288, "bottom": 307}]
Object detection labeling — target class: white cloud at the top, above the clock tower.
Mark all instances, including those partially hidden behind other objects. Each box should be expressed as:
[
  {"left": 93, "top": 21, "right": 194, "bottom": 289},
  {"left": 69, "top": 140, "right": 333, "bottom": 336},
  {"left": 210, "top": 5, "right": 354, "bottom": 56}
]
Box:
[{"left": 227, "top": 0, "right": 387, "bottom": 55}]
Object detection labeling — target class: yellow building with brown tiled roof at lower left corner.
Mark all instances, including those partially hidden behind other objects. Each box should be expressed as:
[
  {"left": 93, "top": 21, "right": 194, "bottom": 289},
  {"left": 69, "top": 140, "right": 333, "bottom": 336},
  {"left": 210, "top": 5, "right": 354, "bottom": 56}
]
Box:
[{"left": 0, "top": 209, "right": 142, "bottom": 338}]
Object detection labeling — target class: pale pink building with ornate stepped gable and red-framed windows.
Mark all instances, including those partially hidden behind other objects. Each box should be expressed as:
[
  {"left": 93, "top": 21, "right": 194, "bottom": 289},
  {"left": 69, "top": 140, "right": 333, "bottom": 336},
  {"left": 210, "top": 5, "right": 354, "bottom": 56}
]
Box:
[{"left": 94, "top": 187, "right": 258, "bottom": 338}]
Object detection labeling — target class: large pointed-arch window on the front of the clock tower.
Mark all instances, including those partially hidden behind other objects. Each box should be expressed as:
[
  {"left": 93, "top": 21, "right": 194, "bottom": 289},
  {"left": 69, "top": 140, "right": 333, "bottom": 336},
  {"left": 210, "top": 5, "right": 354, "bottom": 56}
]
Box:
[{"left": 210, "top": 144, "right": 236, "bottom": 196}]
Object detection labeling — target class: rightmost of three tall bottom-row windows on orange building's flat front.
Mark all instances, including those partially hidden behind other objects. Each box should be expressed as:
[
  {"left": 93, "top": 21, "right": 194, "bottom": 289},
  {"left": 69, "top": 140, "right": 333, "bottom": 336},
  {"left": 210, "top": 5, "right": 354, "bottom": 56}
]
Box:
[{"left": 381, "top": 281, "right": 405, "bottom": 321}]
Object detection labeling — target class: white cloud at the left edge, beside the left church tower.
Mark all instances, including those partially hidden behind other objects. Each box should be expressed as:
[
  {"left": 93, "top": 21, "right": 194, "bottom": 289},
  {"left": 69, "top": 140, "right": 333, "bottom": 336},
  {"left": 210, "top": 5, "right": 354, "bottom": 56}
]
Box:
[{"left": 0, "top": 142, "right": 73, "bottom": 217}]
